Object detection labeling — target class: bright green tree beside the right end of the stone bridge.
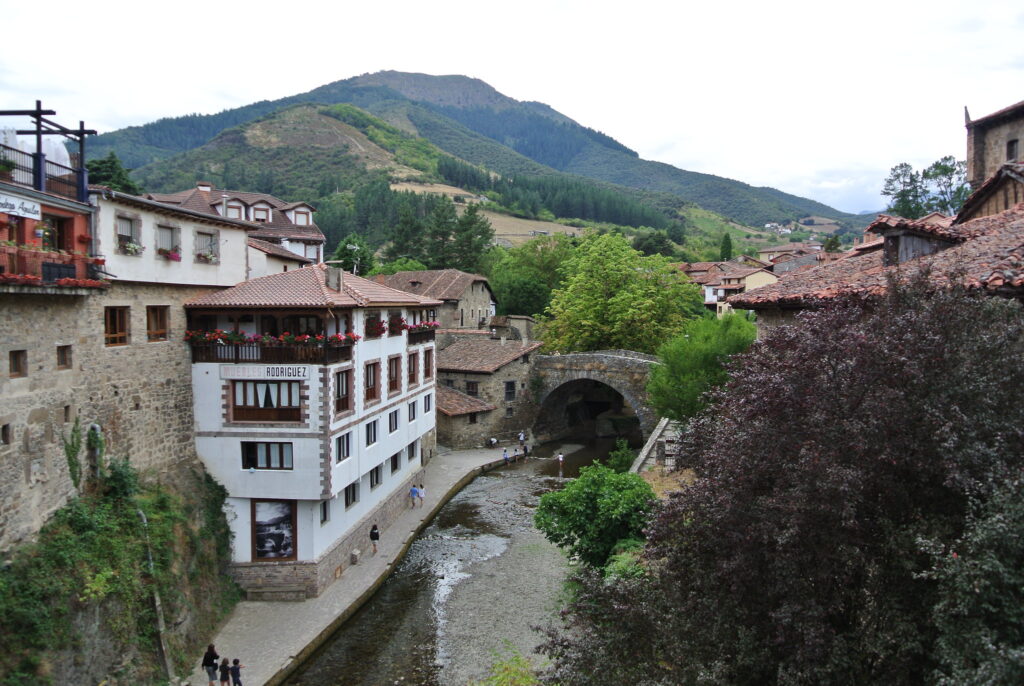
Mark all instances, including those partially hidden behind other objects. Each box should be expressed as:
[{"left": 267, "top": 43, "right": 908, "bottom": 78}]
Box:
[{"left": 647, "top": 312, "right": 757, "bottom": 422}]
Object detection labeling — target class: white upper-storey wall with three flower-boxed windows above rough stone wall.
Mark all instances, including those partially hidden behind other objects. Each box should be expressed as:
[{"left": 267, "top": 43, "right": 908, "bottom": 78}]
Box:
[{"left": 91, "top": 192, "right": 248, "bottom": 287}]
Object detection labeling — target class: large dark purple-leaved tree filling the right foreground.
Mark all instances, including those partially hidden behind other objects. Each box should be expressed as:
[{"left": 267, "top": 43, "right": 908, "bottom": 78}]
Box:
[{"left": 545, "top": 287, "right": 1024, "bottom": 686}]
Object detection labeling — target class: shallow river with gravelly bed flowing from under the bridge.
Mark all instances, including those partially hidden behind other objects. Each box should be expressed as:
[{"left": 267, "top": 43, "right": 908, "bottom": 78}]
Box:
[{"left": 286, "top": 439, "right": 613, "bottom": 686}]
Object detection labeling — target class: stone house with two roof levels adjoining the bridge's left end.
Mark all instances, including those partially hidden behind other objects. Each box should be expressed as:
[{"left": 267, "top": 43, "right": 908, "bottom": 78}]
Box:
[{"left": 437, "top": 336, "right": 543, "bottom": 447}]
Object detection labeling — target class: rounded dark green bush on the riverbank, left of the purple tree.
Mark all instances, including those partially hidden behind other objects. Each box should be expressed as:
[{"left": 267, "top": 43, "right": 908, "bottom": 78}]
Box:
[{"left": 534, "top": 465, "right": 655, "bottom": 567}]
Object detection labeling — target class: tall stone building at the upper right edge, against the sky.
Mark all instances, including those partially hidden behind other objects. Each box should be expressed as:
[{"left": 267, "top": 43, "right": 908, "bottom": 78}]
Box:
[{"left": 964, "top": 100, "right": 1024, "bottom": 186}]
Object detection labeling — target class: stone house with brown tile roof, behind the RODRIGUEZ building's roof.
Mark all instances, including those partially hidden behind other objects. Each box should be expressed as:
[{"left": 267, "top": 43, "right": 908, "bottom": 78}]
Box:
[{"left": 374, "top": 269, "right": 497, "bottom": 329}]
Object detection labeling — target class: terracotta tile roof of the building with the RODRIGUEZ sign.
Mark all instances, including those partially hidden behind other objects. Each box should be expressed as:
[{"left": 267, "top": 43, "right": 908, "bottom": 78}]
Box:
[{"left": 185, "top": 264, "right": 440, "bottom": 308}]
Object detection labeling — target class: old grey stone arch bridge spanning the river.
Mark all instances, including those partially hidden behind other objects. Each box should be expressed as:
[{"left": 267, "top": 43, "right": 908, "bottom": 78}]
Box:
[{"left": 532, "top": 350, "right": 658, "bottom": 440}]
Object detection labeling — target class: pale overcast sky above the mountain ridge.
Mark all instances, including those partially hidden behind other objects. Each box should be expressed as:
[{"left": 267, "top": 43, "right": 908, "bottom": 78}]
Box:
[{"left": 0, "top": 0, "right": 1024, "bottom": 212}]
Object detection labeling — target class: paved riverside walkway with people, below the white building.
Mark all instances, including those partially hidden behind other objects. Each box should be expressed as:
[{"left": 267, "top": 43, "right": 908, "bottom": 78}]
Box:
[{"left": 184, "top": 449, "right": 502, "bottom": 686}]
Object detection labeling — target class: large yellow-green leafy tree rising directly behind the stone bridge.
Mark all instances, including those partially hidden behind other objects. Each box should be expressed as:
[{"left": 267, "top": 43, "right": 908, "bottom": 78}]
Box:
[{"left": 540, "top": 233, "right": 703, "bottom": 352}]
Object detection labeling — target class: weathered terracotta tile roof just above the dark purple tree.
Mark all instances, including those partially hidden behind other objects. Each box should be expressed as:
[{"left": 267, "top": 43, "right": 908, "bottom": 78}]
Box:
[{"left": 728, "top": 203, "right": 1024, "bottom": 309}]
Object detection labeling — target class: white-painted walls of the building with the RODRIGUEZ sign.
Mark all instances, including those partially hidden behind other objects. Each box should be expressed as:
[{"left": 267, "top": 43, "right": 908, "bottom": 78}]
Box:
[{"left": 193, "top": 308, "right": 435, "bottom": 563}]
